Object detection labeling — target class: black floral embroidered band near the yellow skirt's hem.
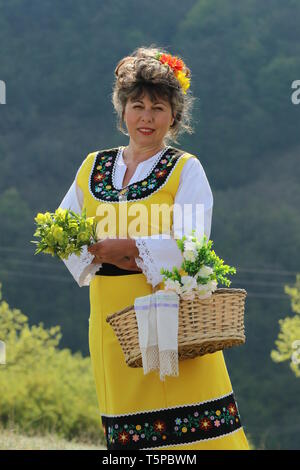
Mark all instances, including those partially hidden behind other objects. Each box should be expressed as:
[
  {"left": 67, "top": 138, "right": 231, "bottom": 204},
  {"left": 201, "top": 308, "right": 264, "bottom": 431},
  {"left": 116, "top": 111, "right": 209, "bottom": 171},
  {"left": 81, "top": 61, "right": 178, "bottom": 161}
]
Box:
[{"left": 102, "top": 393, "right": 242, "bottom": 450}]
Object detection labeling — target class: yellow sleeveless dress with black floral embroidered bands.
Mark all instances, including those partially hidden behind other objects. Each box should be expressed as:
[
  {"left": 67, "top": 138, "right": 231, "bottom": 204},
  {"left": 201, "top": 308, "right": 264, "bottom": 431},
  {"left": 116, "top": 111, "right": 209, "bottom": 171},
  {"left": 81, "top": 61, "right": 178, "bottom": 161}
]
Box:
[{"left": 77, "top": 147, "right": 249, "bottom": 450}]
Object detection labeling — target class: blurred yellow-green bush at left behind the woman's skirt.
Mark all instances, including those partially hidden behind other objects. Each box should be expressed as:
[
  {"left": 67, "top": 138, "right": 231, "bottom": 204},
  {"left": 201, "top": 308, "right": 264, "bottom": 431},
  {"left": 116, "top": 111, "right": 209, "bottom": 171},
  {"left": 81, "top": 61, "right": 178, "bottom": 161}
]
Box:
[{"left": 0, "top": 284, "right": 105, "bottom": 444}]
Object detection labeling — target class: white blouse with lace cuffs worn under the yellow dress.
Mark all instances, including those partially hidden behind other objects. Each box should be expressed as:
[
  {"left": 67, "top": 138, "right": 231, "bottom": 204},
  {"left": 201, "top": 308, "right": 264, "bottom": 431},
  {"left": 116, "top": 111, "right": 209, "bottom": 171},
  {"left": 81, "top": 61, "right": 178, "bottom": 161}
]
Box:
[{"left": 59, "top": 147, "right": 213, "bottom": 287}]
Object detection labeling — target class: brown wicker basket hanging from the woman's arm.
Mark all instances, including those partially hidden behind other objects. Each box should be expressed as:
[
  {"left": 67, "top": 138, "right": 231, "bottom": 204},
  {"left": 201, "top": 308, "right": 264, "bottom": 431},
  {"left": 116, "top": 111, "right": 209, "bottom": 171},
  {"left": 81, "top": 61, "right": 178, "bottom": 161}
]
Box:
[{"left": 106, "top": 288, "right": 247, "bottom": 367}]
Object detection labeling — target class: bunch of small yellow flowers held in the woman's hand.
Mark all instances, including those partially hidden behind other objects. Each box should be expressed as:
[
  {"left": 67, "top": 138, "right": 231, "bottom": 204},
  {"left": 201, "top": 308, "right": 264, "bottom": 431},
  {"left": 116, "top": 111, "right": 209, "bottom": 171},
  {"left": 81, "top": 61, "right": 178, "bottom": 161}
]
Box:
[{"left": 31, "top": 208, "right": 97, "bottom": 259}]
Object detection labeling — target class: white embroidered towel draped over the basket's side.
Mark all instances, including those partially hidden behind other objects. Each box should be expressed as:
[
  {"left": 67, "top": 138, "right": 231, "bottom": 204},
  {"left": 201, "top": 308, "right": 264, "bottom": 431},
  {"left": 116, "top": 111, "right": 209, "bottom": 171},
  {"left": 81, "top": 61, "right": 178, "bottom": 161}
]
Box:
[{"left": 134, "top": 290, "right": 179, "bottom": 381}]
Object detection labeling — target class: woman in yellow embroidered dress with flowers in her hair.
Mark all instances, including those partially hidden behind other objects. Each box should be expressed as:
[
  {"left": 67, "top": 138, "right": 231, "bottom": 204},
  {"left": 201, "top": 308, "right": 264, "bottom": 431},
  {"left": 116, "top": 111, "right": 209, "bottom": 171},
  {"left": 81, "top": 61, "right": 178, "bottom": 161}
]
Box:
[{"left": 60, "top": 47, "right": 249, "bottom": 450}]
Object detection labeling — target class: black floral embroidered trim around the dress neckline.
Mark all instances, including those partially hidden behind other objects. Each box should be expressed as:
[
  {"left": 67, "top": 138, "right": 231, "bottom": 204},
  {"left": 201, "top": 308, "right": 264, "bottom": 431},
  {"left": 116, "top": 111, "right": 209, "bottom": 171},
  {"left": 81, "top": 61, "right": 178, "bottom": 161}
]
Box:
[{"left": 89, "top": 146, "right": 184, "bottom": 202}]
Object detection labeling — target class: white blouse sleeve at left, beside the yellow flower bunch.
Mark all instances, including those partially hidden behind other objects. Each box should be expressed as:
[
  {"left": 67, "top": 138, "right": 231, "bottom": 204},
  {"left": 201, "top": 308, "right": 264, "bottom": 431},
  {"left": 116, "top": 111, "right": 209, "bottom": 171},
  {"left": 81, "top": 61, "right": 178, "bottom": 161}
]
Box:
[{"left": 59, "top": 170, "right": 102, "bottom": 287}]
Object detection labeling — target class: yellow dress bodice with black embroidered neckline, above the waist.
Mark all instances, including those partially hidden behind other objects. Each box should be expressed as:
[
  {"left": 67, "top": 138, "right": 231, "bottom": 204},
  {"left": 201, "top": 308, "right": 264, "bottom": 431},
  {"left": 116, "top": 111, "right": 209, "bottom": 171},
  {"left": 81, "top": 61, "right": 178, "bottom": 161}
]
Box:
[{"left": 77, "top": 146, "right": 197, "bottom": 239}]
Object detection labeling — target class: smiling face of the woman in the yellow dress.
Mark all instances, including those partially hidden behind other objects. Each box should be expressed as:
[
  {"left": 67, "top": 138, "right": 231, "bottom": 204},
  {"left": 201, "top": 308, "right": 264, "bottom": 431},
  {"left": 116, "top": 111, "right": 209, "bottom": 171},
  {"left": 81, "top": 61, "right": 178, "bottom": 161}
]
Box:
[{"left": 124, "top": 93, "right": 174, "bottom": 147}]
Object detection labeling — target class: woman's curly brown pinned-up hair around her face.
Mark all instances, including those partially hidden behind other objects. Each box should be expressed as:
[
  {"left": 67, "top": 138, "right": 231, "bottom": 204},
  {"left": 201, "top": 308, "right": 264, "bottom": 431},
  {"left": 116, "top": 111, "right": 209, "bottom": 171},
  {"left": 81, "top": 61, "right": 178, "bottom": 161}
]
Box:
[{"left": 112, "top": 44, "right": 195, "bottom": 145}]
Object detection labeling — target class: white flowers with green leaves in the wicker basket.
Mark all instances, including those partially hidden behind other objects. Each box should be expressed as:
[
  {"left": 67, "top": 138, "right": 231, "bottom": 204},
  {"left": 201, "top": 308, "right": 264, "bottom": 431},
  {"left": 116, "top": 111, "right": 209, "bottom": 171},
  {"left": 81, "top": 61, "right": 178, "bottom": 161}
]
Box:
[{"left": 160, "top": 230, "right": 236, "bottom": 300}]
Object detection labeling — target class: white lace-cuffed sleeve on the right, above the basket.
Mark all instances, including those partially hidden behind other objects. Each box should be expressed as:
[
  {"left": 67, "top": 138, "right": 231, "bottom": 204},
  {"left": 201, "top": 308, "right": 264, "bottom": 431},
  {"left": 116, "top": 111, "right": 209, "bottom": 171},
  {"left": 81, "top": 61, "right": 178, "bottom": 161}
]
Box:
[{"left": 134, "top": 158, "right": 213, "bottom": 287}]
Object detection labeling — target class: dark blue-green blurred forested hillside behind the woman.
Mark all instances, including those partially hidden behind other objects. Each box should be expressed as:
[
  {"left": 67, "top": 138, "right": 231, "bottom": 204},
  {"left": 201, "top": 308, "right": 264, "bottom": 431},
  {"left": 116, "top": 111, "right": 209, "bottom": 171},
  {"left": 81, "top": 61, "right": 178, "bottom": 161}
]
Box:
[{"left": 0, "top": 0, "right": 300, "bottom": 449}]
